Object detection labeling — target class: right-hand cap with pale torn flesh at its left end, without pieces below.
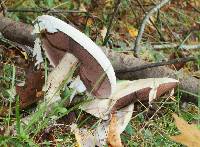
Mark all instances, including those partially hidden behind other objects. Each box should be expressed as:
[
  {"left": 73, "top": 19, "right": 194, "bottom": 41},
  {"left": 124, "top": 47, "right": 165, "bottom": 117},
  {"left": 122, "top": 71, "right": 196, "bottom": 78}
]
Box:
[{"left": 81, "top": 78, "right": 178, "bottom": 120}]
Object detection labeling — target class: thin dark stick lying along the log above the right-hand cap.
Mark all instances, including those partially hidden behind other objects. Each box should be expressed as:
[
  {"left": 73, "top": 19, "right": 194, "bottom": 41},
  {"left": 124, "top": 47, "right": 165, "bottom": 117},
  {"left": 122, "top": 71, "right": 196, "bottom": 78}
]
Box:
[{"left": 116, "top": 57, "right": 196, "bottom": 73}]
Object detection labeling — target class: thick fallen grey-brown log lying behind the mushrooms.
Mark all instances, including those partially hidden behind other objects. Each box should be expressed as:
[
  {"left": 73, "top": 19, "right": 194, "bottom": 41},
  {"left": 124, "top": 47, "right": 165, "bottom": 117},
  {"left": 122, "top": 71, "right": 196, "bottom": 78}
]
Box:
[{"left": 0, "top": 17, "right": 200, "bottom": 102}]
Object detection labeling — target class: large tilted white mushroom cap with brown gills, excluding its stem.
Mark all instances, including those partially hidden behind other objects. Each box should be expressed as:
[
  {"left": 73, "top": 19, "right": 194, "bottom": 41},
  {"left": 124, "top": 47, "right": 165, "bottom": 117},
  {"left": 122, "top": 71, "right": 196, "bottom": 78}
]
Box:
[{"left": 33, "top": 15, "right": 116, "bottom": 98}]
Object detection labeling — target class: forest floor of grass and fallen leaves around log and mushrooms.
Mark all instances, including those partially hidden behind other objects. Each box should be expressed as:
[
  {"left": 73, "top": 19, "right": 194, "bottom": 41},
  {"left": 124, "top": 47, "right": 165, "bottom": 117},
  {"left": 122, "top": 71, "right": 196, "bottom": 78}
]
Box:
[{"left": 0, "top": 0, "right": 200, "bottom": 147}]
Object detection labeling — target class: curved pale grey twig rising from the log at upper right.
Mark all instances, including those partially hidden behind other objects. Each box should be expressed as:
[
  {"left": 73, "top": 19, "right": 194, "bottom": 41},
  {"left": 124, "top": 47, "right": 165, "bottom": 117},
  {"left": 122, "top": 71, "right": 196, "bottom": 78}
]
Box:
[{"left": 134, "top": 0, "right": 171, "bottom": 56}]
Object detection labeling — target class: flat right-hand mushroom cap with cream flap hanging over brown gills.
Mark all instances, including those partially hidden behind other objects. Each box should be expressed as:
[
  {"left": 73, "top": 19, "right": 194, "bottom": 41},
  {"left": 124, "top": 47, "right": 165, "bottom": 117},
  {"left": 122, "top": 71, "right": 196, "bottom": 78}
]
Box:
[{"left": 110, "top": 78, "right": 179, "bottom": 111}]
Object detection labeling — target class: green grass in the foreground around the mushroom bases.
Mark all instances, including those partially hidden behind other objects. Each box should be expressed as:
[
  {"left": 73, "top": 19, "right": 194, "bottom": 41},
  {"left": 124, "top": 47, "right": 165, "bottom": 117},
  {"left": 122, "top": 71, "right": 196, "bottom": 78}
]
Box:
[{"left": 0, "top": 62, "right": 200, "bottom": 147}]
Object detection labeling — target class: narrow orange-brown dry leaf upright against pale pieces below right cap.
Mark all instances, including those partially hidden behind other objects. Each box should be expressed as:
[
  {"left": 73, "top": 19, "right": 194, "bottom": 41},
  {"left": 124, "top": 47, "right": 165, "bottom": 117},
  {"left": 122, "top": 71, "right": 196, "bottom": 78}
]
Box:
[{"left": 107, "top": 114, "right": 123, "bottom": 147}]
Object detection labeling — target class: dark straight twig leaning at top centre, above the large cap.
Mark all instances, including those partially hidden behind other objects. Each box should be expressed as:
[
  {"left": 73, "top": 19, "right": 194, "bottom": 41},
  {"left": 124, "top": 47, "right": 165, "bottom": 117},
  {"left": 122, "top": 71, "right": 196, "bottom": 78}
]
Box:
[{"left": 103, "top": 0, "right": 121, "bottom": 46}]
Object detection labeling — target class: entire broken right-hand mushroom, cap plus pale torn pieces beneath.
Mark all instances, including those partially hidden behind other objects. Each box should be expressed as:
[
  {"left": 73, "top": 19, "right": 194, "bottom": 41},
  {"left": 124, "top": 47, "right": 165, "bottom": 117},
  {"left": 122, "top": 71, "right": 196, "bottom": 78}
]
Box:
[{"left": 79, "top": 78, "right": 178, "bottom": 146}]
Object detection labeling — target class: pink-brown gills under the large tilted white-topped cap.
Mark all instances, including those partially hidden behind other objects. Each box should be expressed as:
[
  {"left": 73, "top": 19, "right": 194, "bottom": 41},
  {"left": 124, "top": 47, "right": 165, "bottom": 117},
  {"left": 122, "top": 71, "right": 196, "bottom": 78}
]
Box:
[{"left": 42, "top": 32, "right": 111, "bottom": 98}]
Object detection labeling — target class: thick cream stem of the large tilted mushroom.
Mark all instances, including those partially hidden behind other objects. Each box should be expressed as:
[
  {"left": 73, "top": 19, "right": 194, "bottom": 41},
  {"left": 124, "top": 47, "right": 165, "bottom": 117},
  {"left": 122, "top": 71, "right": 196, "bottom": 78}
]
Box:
[{"left": 45, "top": 53, "right": 79, "bottom": 105}]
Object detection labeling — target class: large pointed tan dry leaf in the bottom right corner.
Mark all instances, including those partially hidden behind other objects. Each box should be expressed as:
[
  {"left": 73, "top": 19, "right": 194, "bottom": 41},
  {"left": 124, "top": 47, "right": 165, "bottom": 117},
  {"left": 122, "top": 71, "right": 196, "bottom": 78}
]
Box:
[{"left": 170, "top": 114, "right": 200, "bottom": 147}]
